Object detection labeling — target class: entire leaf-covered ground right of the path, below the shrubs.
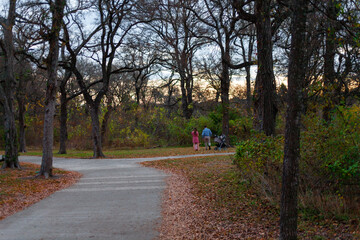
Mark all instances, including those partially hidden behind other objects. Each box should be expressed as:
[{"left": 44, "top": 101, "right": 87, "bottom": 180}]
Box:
[{"left": 142, "top": 156, "right": 360, "bottom": 240}]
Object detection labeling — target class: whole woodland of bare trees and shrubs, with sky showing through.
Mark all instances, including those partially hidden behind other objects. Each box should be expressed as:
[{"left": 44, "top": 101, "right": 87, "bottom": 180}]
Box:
[{"left": 0, "top": 0, "right": 360, "bottom": 239}]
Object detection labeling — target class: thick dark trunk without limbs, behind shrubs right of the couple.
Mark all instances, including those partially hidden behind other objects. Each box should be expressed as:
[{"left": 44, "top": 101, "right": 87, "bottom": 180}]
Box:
[{"left": 254, "top": 0, "right": 278, "bottom": 136}]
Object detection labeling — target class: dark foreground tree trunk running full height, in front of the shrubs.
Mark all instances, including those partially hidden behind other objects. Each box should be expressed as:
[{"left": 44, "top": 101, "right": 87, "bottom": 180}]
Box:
[{"left": 280, "top": 0, "right": 307, "bottom": 240}]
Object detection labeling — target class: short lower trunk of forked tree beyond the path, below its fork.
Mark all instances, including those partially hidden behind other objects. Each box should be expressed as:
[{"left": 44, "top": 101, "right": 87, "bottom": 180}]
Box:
[{"left": 90, "top": 104, "right": 105, "bottom": 158}]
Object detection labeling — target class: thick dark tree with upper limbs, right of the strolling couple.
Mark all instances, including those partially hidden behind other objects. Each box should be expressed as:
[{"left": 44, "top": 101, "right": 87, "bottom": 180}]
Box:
[{"left": 233, "top": 0, "right": 288, "bottom": 136}]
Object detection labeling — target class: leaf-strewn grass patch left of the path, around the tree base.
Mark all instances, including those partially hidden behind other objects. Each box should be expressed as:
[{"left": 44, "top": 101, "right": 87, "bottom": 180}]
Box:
[{"left": 0, "top": 163, "right": 81, "bottom": 220}]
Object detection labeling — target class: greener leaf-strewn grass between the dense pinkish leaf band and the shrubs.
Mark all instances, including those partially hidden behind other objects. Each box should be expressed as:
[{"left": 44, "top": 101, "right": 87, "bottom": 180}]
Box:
[{"left": 143, "top": 156, "right": 360, "bottom": 239}]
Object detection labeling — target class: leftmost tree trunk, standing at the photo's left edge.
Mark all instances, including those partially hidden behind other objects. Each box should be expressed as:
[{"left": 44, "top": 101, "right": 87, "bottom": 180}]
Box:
[{"left": 0, "top": 0, "right": 20, "bottom": 168}]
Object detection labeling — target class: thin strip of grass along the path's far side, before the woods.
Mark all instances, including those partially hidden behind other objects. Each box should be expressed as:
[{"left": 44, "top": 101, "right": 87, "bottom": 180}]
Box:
[{"left": 16, "top": 147, "right": 235, "bottom": 158}]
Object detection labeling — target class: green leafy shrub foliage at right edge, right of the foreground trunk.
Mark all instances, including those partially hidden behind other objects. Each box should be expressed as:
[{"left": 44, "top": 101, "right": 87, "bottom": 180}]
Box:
[{"left": 301, "top": 106, "right": 360, "bottom": 190}]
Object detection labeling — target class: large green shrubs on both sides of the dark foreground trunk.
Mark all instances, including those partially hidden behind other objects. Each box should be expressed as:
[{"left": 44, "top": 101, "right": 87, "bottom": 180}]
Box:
[{"left": 234, "top": 106, "right": 360, "bottom": 216}]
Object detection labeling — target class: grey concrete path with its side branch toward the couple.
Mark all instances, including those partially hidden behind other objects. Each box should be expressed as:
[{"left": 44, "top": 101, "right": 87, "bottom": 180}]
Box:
[{"left": 0, "top": 153, "right": 231, "bottom": 240}]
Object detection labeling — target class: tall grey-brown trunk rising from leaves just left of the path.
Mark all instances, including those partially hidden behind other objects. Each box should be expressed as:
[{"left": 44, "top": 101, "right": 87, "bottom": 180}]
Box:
[{"left": 39, "top": 0, "right": 66, "bottom": 178}]
